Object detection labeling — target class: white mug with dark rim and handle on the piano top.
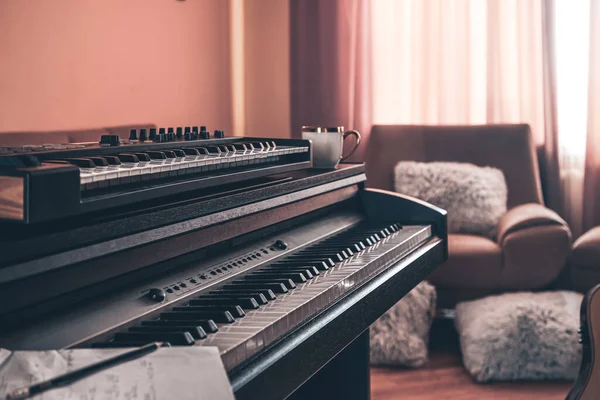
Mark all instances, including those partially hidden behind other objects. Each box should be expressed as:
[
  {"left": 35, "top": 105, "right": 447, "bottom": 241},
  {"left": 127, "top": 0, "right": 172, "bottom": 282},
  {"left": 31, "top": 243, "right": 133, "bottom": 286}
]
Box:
[{"left": 302, "top": 126, "right": 360, "bottom": 168}]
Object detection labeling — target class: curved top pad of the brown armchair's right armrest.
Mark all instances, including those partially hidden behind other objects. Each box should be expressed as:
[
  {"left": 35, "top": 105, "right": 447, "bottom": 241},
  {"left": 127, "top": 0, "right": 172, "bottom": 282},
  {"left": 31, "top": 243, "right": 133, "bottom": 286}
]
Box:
[{"left": 497, "top": 203, "right": 567, "bottom": 247}]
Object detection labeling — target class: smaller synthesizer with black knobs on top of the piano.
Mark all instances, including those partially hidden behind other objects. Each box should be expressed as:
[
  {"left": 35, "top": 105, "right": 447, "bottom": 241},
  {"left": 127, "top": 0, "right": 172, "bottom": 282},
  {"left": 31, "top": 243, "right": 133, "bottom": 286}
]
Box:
[{"left": 0, "top": 127, "right": 312, "bottom": 224}]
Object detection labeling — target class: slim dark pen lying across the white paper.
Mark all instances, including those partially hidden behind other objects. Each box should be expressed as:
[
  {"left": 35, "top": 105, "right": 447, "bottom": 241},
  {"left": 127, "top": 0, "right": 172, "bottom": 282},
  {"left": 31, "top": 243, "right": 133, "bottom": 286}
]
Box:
[{"left": 6, "top": 343, "right": 169, "bottom": 400}]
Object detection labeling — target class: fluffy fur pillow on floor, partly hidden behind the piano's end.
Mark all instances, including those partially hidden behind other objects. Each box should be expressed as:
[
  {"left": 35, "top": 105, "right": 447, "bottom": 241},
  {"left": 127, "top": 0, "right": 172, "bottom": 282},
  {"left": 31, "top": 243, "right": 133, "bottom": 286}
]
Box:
[{"left": 370, "top": 282, "right": 436, "bottom": 368}]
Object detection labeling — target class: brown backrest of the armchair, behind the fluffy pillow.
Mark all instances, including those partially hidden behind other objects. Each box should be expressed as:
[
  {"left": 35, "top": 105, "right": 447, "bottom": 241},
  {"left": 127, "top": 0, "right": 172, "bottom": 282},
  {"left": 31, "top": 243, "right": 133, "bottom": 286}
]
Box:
[{"left": 365, "top": 124, "right": 543, "bottom": 209}]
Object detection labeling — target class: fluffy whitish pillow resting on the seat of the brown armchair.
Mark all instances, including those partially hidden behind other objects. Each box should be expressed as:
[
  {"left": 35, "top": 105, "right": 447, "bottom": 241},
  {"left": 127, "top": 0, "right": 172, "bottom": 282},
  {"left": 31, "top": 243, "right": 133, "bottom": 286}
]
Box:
[{"left": 394, "top": 161, "right": 508, "bottom": 239}]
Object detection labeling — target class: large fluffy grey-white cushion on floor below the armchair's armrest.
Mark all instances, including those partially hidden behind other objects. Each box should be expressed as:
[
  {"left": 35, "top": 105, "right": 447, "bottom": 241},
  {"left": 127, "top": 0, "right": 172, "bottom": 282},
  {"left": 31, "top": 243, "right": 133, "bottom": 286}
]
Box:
[{"left": 455, "top": 291, "right": 583, "bottom": 382}]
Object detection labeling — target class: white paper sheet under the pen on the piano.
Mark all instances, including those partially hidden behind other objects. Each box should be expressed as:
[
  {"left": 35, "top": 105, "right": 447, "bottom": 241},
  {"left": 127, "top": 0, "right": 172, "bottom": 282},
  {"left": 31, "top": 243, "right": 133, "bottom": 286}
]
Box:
[{"left": 0, "top": 346, "right": 234, "bottom": 400}]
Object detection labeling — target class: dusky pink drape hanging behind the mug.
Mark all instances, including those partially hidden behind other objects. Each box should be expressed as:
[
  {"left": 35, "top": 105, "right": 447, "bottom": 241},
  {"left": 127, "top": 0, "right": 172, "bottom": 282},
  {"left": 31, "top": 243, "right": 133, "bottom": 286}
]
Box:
[{"left": 290, "top": 0, "right": 372, "bottom": 159}]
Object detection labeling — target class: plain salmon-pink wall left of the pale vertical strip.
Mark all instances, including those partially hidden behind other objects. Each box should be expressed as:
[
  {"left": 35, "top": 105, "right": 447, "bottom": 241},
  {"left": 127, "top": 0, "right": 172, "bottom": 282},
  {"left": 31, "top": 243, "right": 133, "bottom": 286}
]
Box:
[{"left": 0, "top": 0, "right": 232, "bottom": 132}]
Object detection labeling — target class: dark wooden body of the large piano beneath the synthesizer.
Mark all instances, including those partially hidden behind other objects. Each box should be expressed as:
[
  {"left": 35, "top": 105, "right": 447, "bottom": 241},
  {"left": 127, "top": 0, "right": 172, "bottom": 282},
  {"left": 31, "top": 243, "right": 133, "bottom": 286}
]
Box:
[{"left": 0, "top": 164, "right": 447, "bottom": 399}]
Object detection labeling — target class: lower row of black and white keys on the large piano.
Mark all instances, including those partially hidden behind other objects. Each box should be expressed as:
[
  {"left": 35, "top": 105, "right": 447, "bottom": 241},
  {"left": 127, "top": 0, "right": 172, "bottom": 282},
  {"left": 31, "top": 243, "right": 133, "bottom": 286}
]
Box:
[{"left": 92, "top": 222, "right": 432, "bottom": 369}]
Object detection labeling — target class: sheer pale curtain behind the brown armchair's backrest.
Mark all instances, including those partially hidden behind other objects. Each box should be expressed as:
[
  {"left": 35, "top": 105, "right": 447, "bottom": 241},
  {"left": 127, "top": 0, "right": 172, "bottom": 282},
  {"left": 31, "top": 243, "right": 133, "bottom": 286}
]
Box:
[{"left": 372, "top": 0, "right": 544, "bottom": 141}]
